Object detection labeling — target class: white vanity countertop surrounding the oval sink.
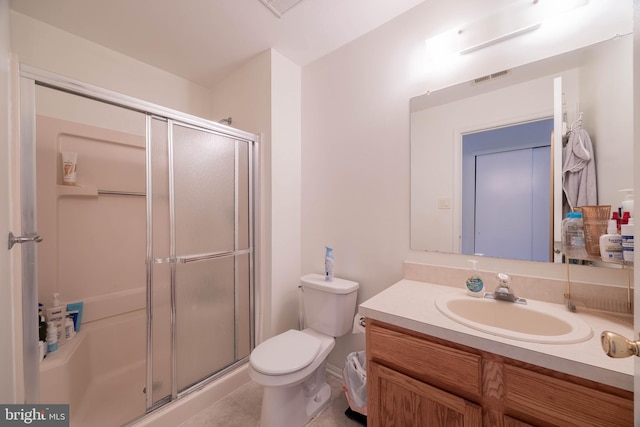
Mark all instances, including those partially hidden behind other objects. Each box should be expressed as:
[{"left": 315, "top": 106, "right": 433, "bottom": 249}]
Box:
[{"left": 359, "top": 280, "right": 634, "bottom": 391}]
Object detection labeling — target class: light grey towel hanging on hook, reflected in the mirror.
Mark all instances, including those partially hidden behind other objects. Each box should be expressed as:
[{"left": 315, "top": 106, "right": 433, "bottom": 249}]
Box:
[{"left": 562, "top": 128, "right": 598, "bottom": 210}]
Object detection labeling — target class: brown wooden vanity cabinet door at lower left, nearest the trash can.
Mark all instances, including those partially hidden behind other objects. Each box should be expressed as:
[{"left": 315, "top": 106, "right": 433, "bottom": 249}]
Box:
[{"left": 367, "top": 362, "right": 482, "bottom": 427}]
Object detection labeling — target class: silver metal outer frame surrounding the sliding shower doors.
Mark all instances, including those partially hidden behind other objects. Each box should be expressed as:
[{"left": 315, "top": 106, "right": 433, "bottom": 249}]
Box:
[{"left": 15, "top": 64, "right": 255, "bottom": 411}]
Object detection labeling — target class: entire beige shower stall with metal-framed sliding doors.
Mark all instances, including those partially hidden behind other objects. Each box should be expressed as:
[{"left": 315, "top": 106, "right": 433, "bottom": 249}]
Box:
[{"left": 20, "top": 66, "right": 258, "bottom": 426}]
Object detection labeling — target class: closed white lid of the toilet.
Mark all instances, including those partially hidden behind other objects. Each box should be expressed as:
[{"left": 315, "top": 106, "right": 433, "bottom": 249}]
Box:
[{"left": 249, "top": 329, "right": 321, "bottom": 375}]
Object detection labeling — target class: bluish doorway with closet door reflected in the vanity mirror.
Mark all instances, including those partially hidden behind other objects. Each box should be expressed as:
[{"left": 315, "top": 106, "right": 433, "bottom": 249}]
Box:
[{"left": 462, "top": 119, "right": 553, "bottom": 261}]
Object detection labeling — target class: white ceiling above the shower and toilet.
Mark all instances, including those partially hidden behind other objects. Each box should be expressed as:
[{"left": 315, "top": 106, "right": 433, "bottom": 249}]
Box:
[{"left": 11, "top": 0, "right": 424, "bottom": 86}]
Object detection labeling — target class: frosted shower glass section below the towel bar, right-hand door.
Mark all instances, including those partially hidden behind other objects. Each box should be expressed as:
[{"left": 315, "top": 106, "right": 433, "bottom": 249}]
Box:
[{"left": 176, "top": 257, "right": 235, "bottom": 390}]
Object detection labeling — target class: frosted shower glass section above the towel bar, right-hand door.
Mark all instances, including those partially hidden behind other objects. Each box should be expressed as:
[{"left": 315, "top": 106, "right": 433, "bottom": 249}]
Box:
[{"left": 173, "top": 125, "right": 235, "bottom": 256}]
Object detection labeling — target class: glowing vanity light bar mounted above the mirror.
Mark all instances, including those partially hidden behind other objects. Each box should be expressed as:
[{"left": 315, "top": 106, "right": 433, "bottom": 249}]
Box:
[{"left": 426, "top": 0, "right": 589, "bottom": 59}]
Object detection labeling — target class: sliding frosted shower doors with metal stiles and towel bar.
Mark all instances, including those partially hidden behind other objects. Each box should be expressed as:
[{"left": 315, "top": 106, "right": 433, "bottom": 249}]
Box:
[{"left": 150, "top": 118, "right": 252, "bottom": 404}]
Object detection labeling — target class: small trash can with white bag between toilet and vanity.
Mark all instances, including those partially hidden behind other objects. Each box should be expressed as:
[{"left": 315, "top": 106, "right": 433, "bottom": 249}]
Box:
[{"left": 342, "top": 351, "right": 367, "bottom": 425}]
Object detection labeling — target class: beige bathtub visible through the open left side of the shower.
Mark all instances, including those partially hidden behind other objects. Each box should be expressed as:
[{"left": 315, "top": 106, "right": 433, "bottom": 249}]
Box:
[{"left": 40, "top": 310, "right": 146, "bottom": 427}]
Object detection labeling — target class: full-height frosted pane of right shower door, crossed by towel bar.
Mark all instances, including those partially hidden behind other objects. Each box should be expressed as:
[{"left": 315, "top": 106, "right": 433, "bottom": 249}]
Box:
[{"left": 173, "top": 125, "right": 236, "bottom": 390}]
